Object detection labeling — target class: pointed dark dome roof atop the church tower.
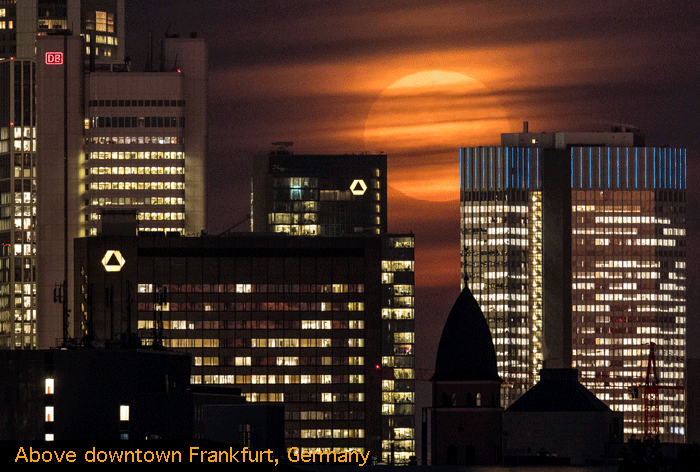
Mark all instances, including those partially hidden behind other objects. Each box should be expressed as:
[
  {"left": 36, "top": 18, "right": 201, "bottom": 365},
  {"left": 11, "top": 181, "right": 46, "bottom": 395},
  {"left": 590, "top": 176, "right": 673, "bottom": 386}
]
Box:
[{"left": 432, "top": 281, "right": 501, "bottom": 382}]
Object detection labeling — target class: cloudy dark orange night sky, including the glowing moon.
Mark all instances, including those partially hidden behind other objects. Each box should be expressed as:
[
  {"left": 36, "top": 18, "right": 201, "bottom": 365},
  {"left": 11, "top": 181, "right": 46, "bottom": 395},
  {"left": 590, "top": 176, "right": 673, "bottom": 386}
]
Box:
[{"left": 126, "top": 0, "right": 700, "bottom": 376}]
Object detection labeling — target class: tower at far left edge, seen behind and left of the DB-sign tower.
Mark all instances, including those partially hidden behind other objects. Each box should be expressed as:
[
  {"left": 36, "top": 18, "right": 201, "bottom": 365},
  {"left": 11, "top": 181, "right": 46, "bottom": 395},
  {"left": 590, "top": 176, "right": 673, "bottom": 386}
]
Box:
[{"left": 0, "top": 0, "right": 124, "bottom": 349}]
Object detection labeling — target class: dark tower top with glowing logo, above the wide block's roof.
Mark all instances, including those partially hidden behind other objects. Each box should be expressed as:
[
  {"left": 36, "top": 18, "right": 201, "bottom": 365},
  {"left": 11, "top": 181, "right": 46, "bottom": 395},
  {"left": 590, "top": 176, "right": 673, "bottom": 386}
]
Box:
[{"left": 251, "top": 151, "right": 386, "bottom": 236}]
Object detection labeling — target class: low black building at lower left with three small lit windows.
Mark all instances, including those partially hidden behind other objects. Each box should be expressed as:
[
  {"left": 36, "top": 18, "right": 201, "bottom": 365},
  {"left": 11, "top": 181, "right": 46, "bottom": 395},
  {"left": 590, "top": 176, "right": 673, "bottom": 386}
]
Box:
[{"left": 0, "top": 343, "right": 284, "bottom": 448}]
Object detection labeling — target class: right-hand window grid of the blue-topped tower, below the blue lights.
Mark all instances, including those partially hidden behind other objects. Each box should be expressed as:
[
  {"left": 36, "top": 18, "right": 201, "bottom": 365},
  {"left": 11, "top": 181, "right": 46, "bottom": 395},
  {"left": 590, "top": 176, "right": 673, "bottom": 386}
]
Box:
[{"left": 572, "top": 190, "right": 686, "bottom": 443}]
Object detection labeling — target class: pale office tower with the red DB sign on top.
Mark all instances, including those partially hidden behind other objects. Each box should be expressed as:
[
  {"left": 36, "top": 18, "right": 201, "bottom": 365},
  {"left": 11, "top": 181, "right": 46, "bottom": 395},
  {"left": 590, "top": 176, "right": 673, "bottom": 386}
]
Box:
[{"left": 36, "top": 35, "right": 207, "bottom": 347}]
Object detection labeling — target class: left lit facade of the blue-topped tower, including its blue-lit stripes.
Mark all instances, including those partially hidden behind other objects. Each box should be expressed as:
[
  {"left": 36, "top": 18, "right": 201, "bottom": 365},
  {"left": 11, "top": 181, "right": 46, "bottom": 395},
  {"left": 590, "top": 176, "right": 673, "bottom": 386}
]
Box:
[{"left": 460, "top": 148, "right": 543, "bottom": 406}]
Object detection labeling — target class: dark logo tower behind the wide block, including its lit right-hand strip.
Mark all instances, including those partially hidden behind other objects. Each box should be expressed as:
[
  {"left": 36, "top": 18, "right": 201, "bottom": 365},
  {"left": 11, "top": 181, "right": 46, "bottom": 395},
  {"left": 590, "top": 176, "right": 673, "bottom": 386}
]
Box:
[{"left": 251, "top": 152, "right": 416, "bottom": 464}]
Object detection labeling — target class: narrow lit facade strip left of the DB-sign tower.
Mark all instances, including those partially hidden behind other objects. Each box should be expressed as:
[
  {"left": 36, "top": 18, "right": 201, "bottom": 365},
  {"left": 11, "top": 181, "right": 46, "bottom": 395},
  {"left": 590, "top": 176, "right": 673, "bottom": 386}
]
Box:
[{"left": 0, "top": 60, "right": 36, "bottom": 349}]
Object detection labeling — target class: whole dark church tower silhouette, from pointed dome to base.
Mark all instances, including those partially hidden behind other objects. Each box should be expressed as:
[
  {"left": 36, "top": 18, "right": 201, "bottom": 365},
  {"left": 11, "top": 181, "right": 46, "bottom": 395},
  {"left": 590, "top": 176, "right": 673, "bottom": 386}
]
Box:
[{"left": 431, "top": 278, "right": 503, "bottom": 465}]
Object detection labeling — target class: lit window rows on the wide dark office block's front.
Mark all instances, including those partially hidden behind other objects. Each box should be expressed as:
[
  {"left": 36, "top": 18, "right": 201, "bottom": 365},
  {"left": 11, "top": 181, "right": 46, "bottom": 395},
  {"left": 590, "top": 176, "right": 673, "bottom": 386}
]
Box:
[{"left": 121, "top": 270, "right": 378, "bottom": 449}]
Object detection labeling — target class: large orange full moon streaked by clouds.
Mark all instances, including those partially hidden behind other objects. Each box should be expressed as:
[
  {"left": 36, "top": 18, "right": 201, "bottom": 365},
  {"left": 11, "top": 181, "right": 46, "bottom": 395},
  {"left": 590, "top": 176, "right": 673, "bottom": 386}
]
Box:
[{"left": 364, "top": 70, "right": 508, "bottom": 201}]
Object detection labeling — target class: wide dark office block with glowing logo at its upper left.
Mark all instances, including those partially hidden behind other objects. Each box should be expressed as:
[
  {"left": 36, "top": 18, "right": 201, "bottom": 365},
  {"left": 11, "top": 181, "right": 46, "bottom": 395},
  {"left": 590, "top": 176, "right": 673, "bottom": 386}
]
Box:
[{"left": 72, "top": 232, "right": 392, "bottom": 456}]
